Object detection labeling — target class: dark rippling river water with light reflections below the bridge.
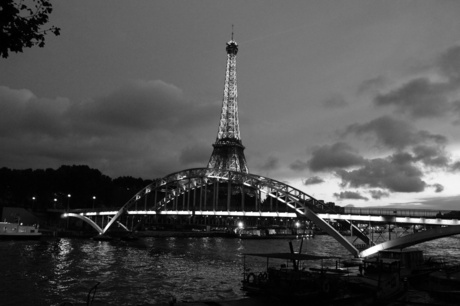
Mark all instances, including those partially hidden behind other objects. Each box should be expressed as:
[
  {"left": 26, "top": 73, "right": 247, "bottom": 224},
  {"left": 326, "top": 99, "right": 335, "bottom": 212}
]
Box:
[{"left": 0, "top": 235, "right": 460, "bottom": 306}]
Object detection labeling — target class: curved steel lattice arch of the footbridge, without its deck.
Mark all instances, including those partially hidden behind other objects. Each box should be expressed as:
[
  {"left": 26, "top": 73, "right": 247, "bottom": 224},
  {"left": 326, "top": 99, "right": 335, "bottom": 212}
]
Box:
[{"left": 99, "top": 168, "right": 359, "bottom": 256}]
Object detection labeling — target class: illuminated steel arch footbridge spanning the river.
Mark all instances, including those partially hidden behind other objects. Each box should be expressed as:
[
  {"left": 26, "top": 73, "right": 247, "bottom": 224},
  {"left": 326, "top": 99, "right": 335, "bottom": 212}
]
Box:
[{"left": 63, "top": 168, "right": 460, "bottom": 257}]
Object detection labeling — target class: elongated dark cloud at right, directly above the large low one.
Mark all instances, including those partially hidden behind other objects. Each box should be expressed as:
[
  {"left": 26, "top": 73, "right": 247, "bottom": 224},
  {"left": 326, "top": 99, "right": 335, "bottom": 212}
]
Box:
[{"left": 345, "top": 116, "right": 447, "bottom": 149}]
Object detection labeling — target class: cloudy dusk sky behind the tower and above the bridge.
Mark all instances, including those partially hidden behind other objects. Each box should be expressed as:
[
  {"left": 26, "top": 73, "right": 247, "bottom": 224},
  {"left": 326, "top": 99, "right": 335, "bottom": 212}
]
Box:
[{"left": 0, "top": 0, "right": 460, "bottom": 209}]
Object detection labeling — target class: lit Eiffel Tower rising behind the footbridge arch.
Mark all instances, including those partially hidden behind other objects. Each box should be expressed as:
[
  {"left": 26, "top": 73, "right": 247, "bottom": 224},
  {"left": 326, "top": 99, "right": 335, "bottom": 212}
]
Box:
[{"left": 208, "top": 31, "right": 249, "bottom": 173}]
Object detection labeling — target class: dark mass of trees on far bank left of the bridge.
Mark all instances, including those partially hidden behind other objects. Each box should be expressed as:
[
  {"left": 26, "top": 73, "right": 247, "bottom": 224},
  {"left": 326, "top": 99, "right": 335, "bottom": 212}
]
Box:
[{"left": 0, "top": 165, "right": 151, "bottom": 210}]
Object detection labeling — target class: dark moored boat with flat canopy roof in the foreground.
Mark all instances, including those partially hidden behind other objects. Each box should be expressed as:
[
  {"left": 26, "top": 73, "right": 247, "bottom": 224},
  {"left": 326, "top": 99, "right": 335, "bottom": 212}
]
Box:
[{"left": 242, "top": 253, "right": 372, "bottom": 303}]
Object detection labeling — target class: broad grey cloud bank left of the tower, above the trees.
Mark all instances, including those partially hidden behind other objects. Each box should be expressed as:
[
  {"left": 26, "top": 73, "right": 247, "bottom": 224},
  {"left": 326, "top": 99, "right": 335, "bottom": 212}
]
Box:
[{"left": 0, "top": 80, "right": 220, "bottom": 178}]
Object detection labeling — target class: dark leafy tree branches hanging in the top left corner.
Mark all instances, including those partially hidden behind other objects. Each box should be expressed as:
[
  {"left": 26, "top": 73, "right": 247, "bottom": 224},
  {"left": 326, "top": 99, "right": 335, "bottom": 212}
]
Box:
[{"left": 0, "top": 0, "right": 61, "bottom": 58}]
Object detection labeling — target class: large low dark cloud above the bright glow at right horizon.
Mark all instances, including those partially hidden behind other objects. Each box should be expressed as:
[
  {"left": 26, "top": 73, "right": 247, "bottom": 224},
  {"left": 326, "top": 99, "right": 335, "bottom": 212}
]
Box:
[{"left": 336, "top": 157, "right": 426, "bottom": 192}]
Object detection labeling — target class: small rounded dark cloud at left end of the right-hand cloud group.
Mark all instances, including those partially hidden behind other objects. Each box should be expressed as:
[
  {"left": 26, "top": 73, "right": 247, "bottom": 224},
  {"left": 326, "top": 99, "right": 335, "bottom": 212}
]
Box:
[{"left": 308, "top": 142, "right": 364, "bottom": 172}]
